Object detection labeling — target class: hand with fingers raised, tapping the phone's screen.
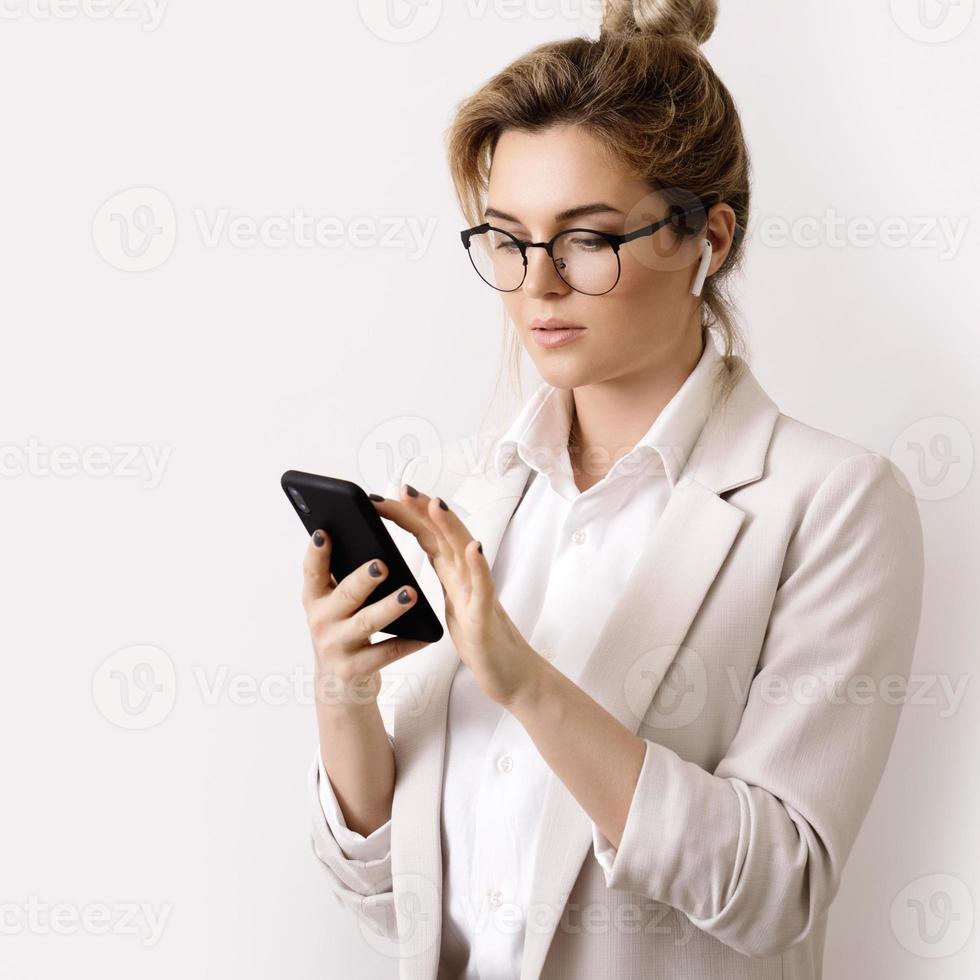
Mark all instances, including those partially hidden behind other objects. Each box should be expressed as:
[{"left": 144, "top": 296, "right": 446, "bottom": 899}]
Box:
[{"left": 374, "top": 484, "right": 541, "bottom": 707}]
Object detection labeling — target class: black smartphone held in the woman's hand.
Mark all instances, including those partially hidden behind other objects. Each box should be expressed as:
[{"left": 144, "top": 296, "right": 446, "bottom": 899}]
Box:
[{"left": 280, "top": 470, "right": 443, "bottom": 643}]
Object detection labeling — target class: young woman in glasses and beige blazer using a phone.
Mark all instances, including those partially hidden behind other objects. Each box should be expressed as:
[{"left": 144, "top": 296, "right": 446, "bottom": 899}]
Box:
[{"left": 304, "top": 0, "right": 923, "bottom": 980}]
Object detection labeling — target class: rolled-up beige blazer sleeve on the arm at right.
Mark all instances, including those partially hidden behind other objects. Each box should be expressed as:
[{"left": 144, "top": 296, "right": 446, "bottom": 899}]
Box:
[{"left": 593, "top": 452, "right": 923, "bottom": 957}]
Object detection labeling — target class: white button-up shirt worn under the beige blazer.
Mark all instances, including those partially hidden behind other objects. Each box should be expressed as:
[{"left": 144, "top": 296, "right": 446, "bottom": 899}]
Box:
[{"left": 317, "top": 336, "right": 721, "bottom": 980}]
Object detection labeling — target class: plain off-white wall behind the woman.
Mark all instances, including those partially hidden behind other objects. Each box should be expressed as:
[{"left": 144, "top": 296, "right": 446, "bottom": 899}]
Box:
[{"left": 0, "top": 0, "right": 980, "bottom": 980}]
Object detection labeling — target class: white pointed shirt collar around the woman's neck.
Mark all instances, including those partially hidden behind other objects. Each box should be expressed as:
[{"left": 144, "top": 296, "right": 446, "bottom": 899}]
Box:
[{"left": 493, "top": 334, "right": 721, "bottom": 488}]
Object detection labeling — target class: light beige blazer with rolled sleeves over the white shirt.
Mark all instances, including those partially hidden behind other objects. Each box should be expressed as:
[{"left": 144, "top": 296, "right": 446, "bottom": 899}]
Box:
[{"left": 310, "top": 358, "right": 923, "bottom": 980}]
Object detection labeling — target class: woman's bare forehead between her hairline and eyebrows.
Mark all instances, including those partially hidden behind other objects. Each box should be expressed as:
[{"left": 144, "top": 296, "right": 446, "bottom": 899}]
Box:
[{"left": 487, "top": 126, "right": 650, "bottom": 219}]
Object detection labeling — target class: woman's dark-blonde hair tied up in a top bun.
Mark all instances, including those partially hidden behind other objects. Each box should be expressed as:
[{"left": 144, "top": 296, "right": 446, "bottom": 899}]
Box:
[{"left": 446, "top": 0, "right": 750, "bottom": 418}]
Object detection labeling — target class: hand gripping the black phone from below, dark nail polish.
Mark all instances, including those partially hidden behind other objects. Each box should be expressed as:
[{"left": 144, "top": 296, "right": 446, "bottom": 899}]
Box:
[{"left": 302, "top": 530, "right": 428, "bottom": 706}]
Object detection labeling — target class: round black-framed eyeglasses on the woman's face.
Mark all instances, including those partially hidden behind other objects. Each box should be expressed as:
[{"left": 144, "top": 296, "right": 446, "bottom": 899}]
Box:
[{"left": 460, "top": 204, "right": 720, "bottom": 296}]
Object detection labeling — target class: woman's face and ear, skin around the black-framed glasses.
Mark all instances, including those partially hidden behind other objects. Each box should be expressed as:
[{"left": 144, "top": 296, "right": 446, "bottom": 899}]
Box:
[{"left": 487, "top": 126, "right": 735, "bottom": 388}]
